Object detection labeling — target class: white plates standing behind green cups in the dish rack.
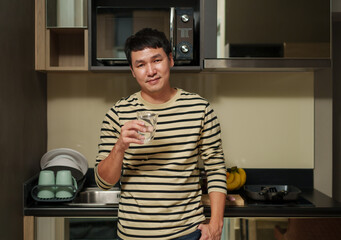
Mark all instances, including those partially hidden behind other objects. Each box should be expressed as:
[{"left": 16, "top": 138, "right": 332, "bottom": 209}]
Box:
[{"left": 40, "top": 148, "right": 88, "bottom": 180}]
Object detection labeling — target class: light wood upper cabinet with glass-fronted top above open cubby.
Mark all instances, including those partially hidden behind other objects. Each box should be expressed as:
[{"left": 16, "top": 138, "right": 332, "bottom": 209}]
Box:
[{"left": 35, "top": 0, "right": 88, "bottom": 71}]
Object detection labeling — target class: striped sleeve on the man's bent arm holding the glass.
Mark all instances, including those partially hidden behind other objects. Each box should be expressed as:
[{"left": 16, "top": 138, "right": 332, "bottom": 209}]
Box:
[{"left": 94, "top": 107, "right": 121, "bottom": 190}]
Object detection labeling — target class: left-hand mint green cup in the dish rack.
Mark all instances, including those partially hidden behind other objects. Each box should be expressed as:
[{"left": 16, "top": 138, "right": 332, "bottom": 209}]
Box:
[{"left": 37, "top": 170, "right": 55, "bottom": 199}]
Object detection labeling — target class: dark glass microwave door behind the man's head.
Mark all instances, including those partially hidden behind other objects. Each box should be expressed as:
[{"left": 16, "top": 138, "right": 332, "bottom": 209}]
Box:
[{"left": 96, "top": 8, "right": 170, "bottom": 66}]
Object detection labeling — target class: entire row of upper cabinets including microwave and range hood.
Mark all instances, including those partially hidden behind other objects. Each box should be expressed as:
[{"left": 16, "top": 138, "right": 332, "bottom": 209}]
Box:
[{"left": 35, "top": 0, "right": 331, "bottom": 71}]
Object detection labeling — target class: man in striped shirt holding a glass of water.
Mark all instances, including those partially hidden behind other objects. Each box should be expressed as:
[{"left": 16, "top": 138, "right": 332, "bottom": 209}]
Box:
[{"left": 95, "top": 29, "right": 226, "bottom": 240}]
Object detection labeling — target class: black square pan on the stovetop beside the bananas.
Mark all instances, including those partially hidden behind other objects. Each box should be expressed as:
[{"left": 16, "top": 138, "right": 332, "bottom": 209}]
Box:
[{"left": 244, "top": 185, "right": 301, "bottom": 201}]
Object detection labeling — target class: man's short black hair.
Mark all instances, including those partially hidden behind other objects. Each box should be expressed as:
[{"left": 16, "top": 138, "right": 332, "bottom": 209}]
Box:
[{"left": 124, "top": 28, "right": 172, "bottom": 66}]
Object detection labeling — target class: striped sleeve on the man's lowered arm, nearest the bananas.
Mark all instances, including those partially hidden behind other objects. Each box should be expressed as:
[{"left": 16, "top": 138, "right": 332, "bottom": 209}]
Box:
[{"left": 199, "top": 103, "right": 227, "bottom": 194}]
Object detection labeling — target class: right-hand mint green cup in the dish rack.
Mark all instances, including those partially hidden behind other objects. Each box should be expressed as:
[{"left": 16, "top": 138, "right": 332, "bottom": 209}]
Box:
[{"left": 56, "top": 170, "right": 77, "bottom": 198}]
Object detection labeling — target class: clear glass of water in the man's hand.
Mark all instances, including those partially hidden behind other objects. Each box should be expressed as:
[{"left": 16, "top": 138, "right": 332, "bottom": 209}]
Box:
[{"left": 137, "top": 111, "right": 158, "bottom": 144}]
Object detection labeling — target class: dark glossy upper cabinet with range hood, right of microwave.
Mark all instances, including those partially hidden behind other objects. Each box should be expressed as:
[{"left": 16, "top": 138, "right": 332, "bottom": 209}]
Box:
[{"left": 204, "top": 0, "right": 331, "bottom": 70}]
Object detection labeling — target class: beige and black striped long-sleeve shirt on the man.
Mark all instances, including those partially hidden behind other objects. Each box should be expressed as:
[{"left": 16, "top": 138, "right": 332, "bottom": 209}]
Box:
[{"left": 95, "top": 89, "right": 226, "bottom": 240}]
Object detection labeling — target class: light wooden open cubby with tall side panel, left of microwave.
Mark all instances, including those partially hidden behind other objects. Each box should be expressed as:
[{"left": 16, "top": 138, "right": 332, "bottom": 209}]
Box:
[{"left": 35, "top": 0, "right": 88, "bottom": 71}]
